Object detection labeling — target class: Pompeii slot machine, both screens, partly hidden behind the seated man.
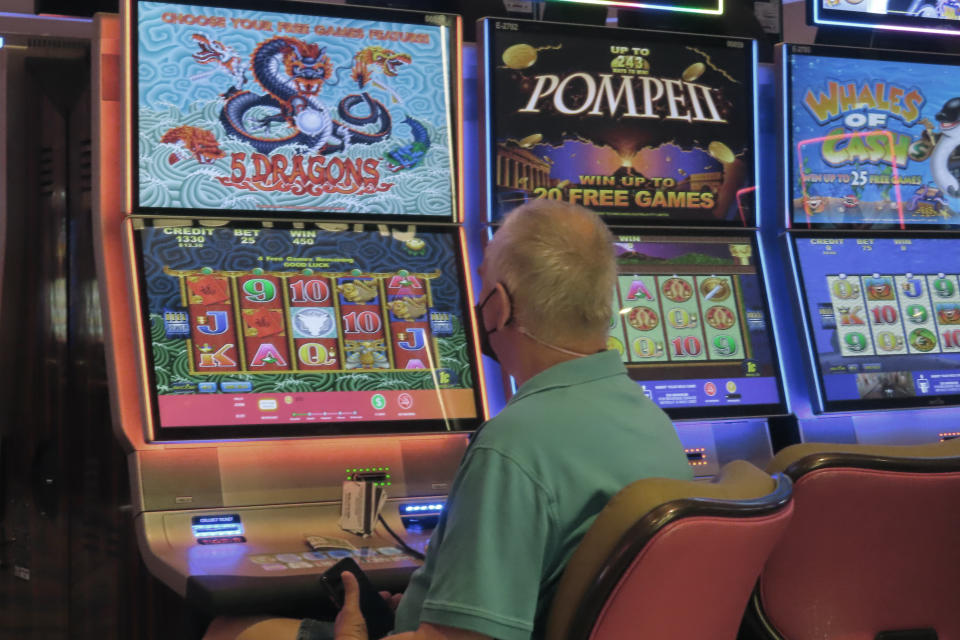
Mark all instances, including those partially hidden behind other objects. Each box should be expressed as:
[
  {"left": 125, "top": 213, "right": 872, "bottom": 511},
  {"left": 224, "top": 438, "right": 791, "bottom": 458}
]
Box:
[{"left": 478, "top": 18, "right": 785, "bottom": 475}]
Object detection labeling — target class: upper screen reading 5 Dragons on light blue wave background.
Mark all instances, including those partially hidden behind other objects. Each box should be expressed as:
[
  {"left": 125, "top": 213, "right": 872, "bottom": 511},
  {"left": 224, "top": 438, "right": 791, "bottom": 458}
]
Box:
[{"left": 126, "top": 0, "right": 461, "bottom": 222}]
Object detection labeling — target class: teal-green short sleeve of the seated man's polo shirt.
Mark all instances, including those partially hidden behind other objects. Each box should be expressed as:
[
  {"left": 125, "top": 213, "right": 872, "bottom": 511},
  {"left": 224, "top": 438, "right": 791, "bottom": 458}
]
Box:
[{"left": 420, "top": 448, "right": 556, "bottom": 640}]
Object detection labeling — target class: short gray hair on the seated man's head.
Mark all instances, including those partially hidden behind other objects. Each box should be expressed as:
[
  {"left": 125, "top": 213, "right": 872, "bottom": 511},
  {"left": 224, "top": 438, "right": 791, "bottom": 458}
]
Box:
[{"left": 484, "top": 200, "right": 617, "bottom": 342}]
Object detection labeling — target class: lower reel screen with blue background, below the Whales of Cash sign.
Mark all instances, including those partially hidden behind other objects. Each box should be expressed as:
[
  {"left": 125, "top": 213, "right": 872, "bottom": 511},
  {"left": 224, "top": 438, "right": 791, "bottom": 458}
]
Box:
[{"left": 794, "top": 234, "right": 960, "bottom": 411}]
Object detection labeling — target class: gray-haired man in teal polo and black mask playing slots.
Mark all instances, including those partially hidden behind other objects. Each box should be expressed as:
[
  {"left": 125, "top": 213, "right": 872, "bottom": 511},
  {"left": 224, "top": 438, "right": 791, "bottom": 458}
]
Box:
[{"left": 206, "top": 200, "right": 692, "bottom": 640}]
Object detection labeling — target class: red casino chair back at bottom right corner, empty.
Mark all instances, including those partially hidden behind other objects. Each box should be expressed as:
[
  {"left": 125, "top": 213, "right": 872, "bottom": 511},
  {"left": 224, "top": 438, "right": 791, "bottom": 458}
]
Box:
[{"left": 741, "top": 440, "right": 960, "bottom": 640}]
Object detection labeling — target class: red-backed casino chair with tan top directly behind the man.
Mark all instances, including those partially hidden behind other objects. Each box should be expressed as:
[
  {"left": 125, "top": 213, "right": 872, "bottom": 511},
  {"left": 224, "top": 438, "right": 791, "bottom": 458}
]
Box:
[{"left": 546, "top": 460, "right": 793, "bottom": 640}]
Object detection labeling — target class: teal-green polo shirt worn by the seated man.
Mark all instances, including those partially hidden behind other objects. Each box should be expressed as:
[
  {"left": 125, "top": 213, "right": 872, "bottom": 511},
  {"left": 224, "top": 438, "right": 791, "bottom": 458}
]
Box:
[{"left": 396, "top": 351, "right": 693, "bottom": 640}]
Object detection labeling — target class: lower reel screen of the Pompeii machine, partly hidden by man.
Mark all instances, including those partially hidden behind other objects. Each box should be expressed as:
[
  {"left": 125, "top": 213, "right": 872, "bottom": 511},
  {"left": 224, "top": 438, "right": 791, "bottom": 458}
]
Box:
[{"left": 608, "top": 234, "right": 783, "bottom": 417}]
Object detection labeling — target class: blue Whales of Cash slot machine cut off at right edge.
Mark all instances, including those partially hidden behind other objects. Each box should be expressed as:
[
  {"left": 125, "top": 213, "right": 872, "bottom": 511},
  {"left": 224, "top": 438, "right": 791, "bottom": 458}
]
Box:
[{"left": 778, "top": 45, "right": 960, "bottom": 443}]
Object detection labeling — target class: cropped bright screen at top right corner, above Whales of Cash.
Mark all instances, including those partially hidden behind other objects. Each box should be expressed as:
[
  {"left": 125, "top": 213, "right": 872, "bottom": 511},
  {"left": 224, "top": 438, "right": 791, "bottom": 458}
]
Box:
[{"left": 807, "top": 0, "right": 960, "bottom": 36}]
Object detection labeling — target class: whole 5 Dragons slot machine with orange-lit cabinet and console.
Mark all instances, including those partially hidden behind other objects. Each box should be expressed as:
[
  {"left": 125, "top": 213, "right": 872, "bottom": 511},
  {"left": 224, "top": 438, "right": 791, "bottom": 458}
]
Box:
[{"left": 94, "top": 0, "right": 487, "bottom": 615}]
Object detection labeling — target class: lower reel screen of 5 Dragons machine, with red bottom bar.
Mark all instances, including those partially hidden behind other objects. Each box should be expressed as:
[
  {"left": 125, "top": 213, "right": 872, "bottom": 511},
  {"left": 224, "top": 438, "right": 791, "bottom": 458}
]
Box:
[{"left": 135, "top": 221, "right": 481, "bottom": 438}]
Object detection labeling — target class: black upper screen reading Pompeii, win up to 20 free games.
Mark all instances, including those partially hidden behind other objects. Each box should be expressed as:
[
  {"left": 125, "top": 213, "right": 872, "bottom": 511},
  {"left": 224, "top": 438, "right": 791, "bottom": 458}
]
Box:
[{"left": 481, "top": 19, "right": 758, "bottom": 226}]
